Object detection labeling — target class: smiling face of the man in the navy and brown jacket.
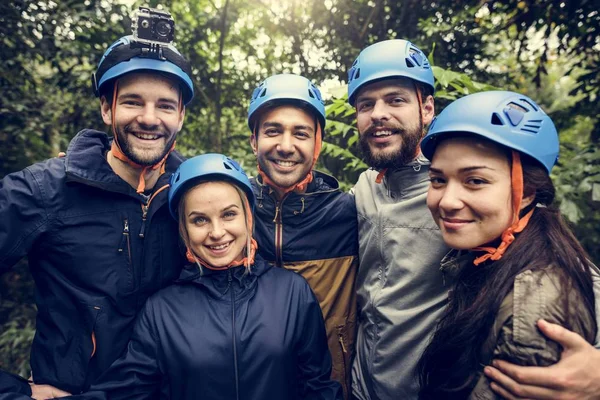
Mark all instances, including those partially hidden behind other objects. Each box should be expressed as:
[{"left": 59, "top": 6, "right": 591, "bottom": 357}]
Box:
[{"left": 252, "top": 105, "right": 315, "bottom": 195}]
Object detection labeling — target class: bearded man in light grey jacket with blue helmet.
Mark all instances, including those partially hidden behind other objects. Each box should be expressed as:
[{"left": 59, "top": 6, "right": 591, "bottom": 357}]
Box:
[{"left": 348, "top": 40, "right": 452, "bottom": 400}]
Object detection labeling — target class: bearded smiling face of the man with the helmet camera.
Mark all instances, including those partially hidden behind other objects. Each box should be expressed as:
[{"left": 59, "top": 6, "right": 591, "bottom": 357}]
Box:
[{"left": 101, "top": 72, "right": 185, "bottom": 166}]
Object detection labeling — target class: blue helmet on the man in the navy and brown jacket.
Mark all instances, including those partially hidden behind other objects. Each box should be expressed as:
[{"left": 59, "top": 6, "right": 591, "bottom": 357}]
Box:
[{"left": 248, "top": 74, "right": 325, "bottom": 132}]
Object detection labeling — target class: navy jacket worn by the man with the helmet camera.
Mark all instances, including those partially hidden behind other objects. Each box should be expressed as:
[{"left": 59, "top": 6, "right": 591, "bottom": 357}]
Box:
[{"left": 0, "top": 130, "right": 184, "bottom": 393}]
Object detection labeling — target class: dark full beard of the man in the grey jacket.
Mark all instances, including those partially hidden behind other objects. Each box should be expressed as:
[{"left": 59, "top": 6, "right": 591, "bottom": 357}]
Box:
[{"left": 358, "top": 122, "right": 423, "bottom": 170}]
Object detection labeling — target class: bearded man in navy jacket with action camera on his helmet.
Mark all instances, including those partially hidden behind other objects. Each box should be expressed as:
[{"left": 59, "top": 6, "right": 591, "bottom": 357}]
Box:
[{"left": 0, "top": 8, "right": 193, "bottom": 398}]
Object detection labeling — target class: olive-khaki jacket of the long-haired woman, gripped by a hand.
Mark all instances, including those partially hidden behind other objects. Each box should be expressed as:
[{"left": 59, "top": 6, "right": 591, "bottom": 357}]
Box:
[{"left": 469, "top": 267, "right": 596, "bottom": 400}]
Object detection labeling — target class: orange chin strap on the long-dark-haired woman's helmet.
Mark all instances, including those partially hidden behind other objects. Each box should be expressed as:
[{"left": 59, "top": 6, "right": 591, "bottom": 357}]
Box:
[{"left": 473, "top": 150, "right": 534, "bottom": 265}]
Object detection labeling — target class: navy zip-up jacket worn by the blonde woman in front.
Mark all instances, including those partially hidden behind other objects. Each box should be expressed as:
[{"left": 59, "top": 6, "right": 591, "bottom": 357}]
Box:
[{"left": 70, "top": 257, "right": 342, "bottom": 400}]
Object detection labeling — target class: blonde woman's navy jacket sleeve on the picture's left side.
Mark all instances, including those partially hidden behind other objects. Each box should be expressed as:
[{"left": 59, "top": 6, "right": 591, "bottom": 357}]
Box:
[{"left": 68, "top": 299, "right": 162, "bottom": 400}]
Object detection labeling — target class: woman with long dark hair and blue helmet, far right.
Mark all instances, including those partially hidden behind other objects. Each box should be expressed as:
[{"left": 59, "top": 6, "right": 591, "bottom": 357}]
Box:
[{"left": 419, "top": 91, "right": 597, "bottom": 399}]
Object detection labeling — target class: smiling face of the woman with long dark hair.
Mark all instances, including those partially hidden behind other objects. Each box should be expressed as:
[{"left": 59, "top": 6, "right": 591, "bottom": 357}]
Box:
[{"left": 427, "top": 137, "right": 516, "bottom": 250}]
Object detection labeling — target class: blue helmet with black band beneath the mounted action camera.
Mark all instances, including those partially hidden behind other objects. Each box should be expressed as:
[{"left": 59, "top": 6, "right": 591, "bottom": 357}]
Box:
[{"left": 92, "top": 35, "right": 194, "bottom": 105}]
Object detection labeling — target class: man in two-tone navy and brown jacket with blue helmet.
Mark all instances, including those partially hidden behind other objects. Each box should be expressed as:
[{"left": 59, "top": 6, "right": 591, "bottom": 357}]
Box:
[{"left": 248, "top": 74, "right": 358, "bottom": 398}]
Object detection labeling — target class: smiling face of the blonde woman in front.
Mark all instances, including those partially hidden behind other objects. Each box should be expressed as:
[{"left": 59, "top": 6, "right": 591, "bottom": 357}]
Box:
[{"left": 182, "top": 182, "right": 248, "bottom": 268}]
